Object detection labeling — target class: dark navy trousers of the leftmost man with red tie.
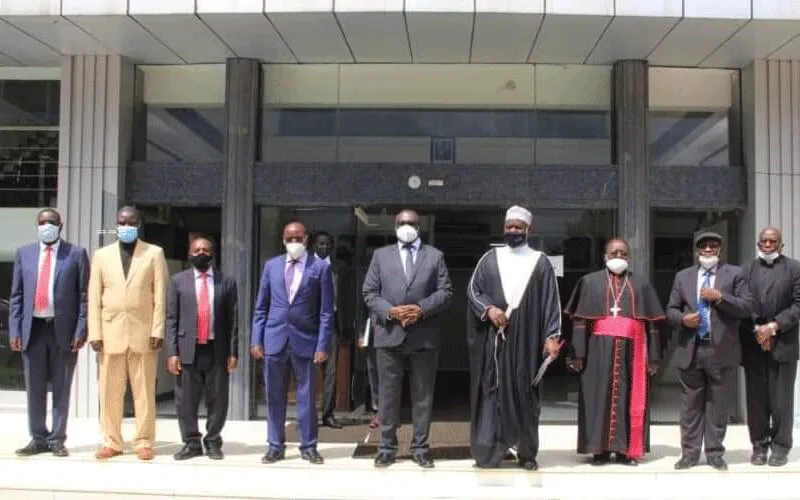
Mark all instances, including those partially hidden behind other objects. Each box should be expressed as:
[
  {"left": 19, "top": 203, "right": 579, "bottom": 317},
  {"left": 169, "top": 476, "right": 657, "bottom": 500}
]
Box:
[{"left": 22, "top": 318, "right": 78, "bottom": 443}]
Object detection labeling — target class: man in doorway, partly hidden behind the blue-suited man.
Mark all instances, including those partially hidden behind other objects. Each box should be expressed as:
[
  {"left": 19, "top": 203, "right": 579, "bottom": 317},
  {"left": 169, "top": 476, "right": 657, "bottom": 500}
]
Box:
[{"left": 311, "top": 231, "right": 342, "bottom": 429}]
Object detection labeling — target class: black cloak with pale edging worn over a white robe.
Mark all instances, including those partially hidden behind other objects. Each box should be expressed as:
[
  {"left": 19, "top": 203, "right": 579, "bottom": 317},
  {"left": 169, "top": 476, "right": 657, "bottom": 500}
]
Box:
[{"left": 467, "top": 249, "right": 561, "bottom": 467}]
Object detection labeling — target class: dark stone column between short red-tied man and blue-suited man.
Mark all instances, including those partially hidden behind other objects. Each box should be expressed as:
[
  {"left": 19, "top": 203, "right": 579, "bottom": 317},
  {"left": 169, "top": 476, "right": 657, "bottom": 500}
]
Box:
[{"left": 221, "top": 59, "right": 261, "bottom": 420}]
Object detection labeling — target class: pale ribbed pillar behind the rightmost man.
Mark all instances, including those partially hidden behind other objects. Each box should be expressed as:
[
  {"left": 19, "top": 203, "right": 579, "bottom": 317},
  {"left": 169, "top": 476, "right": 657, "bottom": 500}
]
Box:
[{"left": 739, "top": 60, "right": 800, "bottom": 430}]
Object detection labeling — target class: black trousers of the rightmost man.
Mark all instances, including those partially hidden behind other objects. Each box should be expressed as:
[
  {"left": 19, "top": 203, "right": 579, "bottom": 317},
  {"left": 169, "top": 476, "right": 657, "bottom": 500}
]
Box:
[{"left": 744, "top": 349, "right": 797, "bottom": 453}]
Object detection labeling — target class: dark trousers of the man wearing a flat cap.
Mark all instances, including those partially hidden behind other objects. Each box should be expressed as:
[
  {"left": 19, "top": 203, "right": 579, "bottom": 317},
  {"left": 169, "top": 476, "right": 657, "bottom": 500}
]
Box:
[{"left": 679, "top": 341, "right": 736, "bottom": 459}]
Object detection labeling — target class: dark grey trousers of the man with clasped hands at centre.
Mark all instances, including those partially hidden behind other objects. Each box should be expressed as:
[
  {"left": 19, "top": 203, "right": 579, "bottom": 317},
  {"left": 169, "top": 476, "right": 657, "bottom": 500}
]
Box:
[{"left": 376, "top": 346, "right": 439, "bottom": 454}]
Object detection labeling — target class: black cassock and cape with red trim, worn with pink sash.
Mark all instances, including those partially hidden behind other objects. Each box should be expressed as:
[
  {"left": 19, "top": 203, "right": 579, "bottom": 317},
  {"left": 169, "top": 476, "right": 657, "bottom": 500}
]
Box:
[{"left": 565, "top": 269, "right": 665, "bottom": 454}]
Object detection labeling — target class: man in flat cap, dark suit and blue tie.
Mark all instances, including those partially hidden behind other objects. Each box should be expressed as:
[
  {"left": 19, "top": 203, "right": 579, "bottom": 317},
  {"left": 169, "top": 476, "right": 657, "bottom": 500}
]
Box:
[{"left": 667, "top": 232, "right": 750, "bottom": 470}]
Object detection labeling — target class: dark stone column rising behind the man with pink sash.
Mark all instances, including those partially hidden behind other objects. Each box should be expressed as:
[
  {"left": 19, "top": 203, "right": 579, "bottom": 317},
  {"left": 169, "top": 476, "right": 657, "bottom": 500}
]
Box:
[{"left": 612, "top": 60, "right": 651, "bottom": 277}]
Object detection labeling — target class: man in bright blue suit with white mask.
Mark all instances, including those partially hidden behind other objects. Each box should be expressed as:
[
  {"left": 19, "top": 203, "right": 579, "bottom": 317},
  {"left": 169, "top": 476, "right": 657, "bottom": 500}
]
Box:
[{"left": 250, "top": 222, "right": 334, "bottom": 464}]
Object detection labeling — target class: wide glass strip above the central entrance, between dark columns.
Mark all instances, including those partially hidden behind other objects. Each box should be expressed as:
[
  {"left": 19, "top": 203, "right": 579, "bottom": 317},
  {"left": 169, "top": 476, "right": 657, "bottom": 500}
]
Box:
[{"left": 261, "top": 108, "right": 611, "bottom": 165}]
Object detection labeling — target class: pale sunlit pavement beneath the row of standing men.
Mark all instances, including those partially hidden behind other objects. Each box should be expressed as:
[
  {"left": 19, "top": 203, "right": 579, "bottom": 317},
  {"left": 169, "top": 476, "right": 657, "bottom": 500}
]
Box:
[{"left": 0, "top": 414, "right": 800, "bottom": 500}]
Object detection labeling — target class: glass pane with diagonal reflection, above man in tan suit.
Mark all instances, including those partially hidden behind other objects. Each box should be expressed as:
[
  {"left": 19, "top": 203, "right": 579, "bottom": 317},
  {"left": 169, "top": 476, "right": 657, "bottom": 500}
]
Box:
[{"left": 142, "top": 105, "right": 225, "bottom": 163}]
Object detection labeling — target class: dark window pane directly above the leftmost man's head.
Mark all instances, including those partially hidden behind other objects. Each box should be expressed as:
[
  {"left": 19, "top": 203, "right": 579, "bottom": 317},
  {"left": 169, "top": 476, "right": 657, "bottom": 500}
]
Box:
[{"left": 0, "top": 129, "right": 58, "bottom": 207}]
